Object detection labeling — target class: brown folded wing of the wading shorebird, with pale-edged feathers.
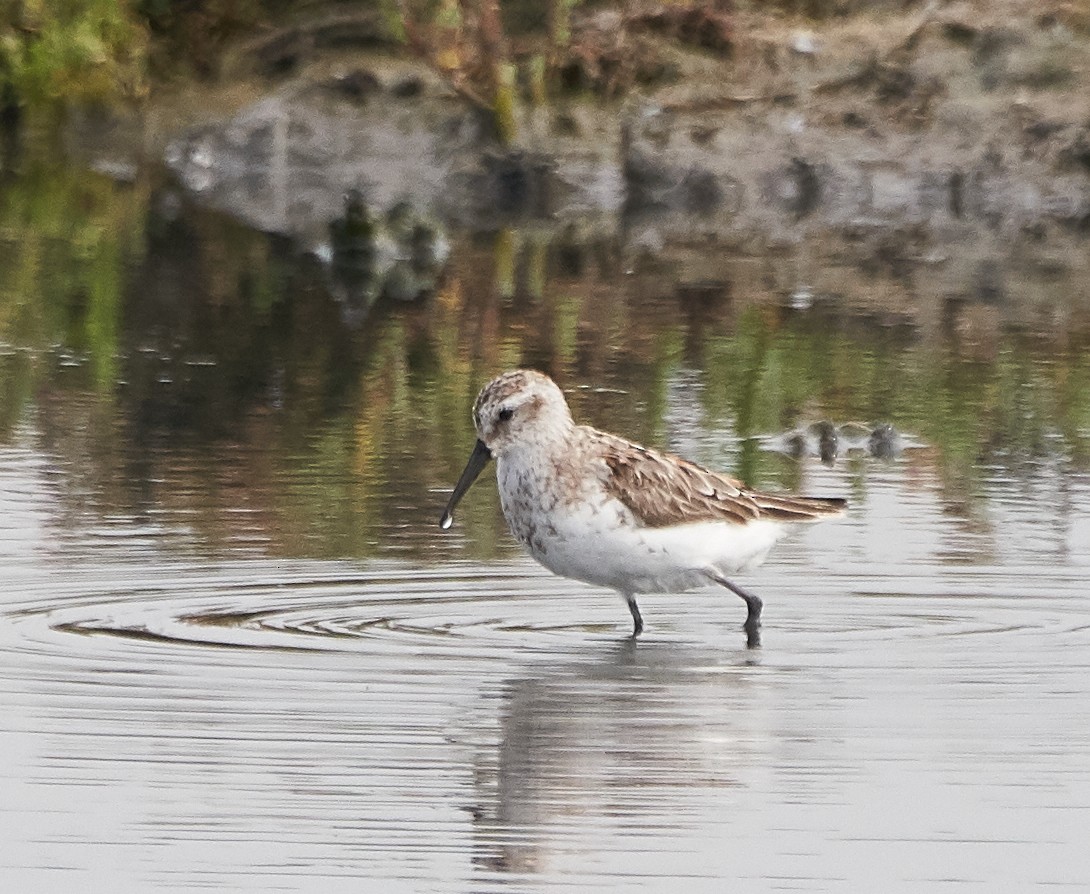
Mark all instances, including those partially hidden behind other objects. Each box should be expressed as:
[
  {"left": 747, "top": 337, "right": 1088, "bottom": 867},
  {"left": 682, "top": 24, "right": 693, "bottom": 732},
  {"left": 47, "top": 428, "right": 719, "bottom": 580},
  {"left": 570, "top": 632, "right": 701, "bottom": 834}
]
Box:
[{"left": 594, "top": 432, "right": 846, "bottom": 528}]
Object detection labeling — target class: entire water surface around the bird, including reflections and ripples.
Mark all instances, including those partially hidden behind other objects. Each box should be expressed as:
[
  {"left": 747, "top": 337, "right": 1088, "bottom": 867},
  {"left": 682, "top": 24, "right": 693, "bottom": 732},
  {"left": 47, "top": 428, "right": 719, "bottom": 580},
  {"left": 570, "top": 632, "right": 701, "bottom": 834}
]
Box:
[{"left": 0, "top": 156, "right": 1090, "bottom": 892}]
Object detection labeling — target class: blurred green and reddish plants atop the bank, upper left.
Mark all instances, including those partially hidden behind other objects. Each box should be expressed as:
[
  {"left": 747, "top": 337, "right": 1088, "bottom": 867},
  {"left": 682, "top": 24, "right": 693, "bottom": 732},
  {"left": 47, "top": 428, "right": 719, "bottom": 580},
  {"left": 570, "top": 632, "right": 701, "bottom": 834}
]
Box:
[{"left": 0, "top": 0, "right": 732, "bottom": 143}]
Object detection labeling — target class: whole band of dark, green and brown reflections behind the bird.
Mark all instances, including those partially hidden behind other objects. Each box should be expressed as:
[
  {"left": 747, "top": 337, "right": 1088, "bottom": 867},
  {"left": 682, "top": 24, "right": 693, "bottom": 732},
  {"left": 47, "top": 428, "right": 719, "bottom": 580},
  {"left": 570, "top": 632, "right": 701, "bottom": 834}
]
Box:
[{"left": 0, "top": 195, "right": 1090, "bottom": 557}]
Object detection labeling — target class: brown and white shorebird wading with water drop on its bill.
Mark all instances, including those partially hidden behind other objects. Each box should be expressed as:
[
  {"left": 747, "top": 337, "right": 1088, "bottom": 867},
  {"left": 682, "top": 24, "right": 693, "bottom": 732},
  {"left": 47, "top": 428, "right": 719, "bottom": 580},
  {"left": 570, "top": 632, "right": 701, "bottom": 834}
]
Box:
[{"left": 439, "top": 370, "right": 845, "bottom": 648}]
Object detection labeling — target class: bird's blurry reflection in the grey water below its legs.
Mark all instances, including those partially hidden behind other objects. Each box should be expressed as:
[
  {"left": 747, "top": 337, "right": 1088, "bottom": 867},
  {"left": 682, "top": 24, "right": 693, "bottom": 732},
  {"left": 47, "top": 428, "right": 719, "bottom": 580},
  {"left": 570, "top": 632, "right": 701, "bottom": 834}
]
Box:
[{"left": 472, "top": 639, "right": 771, "bottom": 875}]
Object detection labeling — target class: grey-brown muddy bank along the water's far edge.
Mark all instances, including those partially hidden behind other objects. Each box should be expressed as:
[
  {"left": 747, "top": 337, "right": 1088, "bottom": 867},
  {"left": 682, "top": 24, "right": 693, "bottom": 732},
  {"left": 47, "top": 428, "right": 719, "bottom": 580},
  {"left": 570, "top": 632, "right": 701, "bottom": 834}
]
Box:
[{"left": 147, "top": 3, "right": 1090, "bottom": 237}]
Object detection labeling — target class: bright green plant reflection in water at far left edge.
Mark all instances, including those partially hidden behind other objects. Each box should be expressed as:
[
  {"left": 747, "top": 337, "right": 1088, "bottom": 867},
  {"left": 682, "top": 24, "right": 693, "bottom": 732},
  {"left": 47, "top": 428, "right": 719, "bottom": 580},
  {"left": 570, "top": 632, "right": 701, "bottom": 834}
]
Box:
[{"left": 0, "top": 168, "right": 146, "bottom": 418}]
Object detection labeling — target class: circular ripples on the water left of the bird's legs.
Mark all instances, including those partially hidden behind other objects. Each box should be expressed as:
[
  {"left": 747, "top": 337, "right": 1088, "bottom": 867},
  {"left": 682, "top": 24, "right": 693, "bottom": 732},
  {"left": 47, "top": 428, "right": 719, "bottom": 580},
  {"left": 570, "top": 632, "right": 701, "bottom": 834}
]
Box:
[{"left": 14, "top": 563, "right": 627, "bottom": 652}]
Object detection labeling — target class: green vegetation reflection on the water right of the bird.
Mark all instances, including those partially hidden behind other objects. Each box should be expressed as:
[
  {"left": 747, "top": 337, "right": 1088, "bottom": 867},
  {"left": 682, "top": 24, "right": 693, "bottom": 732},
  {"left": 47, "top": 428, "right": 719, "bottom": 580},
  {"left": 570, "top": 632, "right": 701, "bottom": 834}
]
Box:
[{"left": 705, "top": 310, "right": 1090, "bottom": 498}]
